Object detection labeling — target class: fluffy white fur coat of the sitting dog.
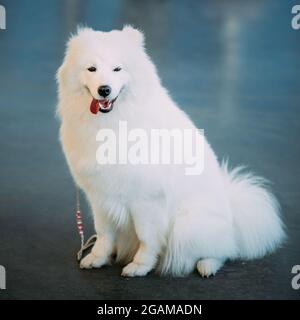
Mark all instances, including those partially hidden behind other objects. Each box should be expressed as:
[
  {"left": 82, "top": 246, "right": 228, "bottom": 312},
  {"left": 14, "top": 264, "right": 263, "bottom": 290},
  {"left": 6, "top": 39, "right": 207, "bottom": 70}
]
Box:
[{"left": 57, "top": 26, "right": 284, "bottom": 276}]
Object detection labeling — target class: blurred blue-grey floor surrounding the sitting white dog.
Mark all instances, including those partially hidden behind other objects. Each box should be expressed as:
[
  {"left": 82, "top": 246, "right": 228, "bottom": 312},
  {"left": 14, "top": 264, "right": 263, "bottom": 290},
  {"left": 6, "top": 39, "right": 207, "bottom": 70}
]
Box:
[{"left": 0, "top": 0, "right": 300, "bottom": 299}]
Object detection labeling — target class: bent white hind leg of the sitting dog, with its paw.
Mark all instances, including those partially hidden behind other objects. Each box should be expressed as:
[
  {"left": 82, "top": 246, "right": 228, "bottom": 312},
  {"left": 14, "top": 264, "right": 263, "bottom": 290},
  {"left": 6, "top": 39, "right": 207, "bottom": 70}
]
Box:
[{"left": 159, "top": 198, "right": 237, "bottom": 276}]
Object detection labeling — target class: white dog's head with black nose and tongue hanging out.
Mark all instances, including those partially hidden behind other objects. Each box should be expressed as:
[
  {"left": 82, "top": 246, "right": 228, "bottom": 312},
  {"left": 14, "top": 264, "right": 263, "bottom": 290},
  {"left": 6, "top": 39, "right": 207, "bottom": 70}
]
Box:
[{"left": 57, "top": 26, "right": 144, "bottom": 113}]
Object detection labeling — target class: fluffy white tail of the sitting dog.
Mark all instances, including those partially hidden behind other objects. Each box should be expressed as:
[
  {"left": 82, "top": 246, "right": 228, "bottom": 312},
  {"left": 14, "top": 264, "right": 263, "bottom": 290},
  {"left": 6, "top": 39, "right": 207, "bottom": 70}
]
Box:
[{"left": 222, "top": 162, "right": 285, "bottom": 259}]
